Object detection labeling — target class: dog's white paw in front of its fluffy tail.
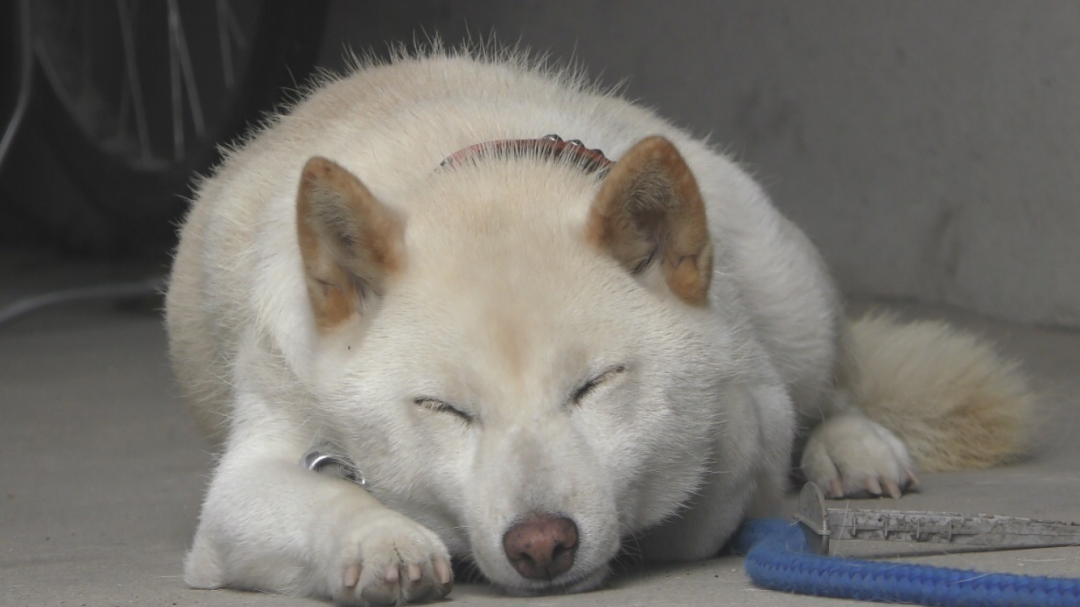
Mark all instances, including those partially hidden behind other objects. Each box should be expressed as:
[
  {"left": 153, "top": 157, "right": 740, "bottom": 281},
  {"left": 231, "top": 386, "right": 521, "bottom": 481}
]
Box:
[{"left": 802, "top": 415, "right": 918, "bottom": 498}]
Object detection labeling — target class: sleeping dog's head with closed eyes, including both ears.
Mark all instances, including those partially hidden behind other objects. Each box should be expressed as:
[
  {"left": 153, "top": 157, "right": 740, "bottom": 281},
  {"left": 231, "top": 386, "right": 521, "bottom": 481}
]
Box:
[{"left": 299, "top": 136, "right": 732, "bottom": 594}]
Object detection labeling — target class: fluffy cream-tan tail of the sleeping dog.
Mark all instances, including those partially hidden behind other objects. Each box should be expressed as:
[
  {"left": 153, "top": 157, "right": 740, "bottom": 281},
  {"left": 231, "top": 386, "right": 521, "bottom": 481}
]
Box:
[{"left": 851, "top": 314, "right": 1036, "bottom": 472}]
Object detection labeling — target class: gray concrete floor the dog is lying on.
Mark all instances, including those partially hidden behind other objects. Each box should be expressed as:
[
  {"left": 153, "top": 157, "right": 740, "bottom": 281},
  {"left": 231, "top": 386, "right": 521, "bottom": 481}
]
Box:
[{"left": 0, "top": 256, "right": 1080, "bottom": 607}]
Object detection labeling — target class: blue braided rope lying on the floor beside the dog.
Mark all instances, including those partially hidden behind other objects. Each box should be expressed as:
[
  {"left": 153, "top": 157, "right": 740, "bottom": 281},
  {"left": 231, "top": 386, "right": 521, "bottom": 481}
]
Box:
[{"left": 731, "top": 518, "right": 1080, "bottom": 607}]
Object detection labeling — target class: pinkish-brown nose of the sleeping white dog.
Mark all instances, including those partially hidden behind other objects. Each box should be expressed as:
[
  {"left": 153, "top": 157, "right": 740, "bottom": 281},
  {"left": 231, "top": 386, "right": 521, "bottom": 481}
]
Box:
[{"left": 502, "top": 514, "right": 578, "bottom": 580}]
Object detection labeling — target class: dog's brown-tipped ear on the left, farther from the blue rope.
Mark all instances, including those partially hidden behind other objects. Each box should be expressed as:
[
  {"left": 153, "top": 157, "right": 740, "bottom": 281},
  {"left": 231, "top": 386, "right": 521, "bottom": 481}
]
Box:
[{"left": 296, "top": 157, "right": 405, "bottom": 328}]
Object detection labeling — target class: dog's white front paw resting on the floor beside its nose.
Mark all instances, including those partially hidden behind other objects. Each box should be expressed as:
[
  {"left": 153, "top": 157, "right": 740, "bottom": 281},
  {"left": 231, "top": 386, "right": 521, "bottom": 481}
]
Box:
[{"left": 327, "top": 510, "right": 454, "bottom": 605}]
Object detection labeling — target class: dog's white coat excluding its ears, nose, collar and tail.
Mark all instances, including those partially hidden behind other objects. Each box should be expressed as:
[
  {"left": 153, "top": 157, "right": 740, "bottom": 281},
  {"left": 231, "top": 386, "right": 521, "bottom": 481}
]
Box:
[{"left": 167, "top": 46, "right": 1032, "bottom": 603}]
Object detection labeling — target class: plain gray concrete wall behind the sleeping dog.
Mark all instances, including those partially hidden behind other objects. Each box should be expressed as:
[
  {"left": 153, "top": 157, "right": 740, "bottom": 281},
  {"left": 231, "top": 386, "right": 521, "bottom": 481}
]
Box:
[{"left": 315, "top": 0, "right": 1080, "bottom": 326}]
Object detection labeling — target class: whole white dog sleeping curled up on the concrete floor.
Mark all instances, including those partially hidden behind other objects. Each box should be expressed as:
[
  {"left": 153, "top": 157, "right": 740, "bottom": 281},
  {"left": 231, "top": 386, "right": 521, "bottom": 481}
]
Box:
[{"left": 166, "top": 51, "right": 1031, "bottom": 604}]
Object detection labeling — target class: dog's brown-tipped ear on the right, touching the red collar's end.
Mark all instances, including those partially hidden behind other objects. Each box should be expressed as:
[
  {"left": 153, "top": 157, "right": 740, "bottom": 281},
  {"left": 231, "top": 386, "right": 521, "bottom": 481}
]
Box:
[{"left": 585, "top": 136, "right": 713, "bottom": 306}]
